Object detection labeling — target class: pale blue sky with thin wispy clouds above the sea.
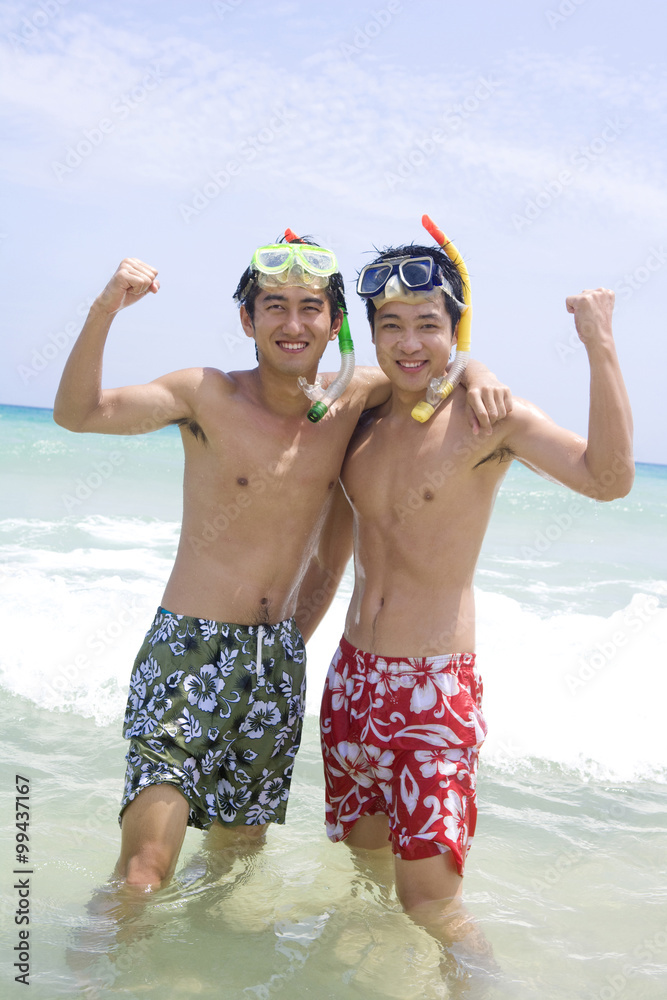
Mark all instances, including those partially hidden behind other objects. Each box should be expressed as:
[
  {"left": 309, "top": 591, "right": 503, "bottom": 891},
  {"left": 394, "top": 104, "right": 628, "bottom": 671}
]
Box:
[{"left": 0, "top": 0, "right": 667, "bottom": 463}]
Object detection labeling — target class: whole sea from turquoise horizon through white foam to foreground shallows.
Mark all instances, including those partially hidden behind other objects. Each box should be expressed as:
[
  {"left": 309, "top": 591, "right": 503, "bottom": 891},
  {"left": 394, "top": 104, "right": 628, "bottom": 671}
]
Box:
[{"left": 0, "top": 407, "right": 667, "bottom": 1000}]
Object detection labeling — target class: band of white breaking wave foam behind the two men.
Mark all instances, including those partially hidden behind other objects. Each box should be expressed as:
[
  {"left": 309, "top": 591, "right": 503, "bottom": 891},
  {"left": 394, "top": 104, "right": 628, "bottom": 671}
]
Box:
[{"left": 0, "top": 518, "right": 667, "bottom": 780}]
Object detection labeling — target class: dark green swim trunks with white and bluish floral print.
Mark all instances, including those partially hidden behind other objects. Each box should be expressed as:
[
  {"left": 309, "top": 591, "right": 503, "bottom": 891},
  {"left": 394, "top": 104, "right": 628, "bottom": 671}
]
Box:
[{"left": 120, "top": 608, "right": 306, "bottom": 830}]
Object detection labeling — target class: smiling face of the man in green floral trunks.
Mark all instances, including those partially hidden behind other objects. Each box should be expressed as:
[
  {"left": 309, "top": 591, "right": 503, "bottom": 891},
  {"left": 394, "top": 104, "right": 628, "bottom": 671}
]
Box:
[{"left": 241, "top": 285, "right": 342, "bottom": 375}]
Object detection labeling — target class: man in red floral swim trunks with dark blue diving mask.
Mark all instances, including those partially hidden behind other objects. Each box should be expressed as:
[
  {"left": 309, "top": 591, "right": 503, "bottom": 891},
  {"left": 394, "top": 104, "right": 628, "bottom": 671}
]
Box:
[{"left": 321, "top": 236, "right": 634, "bottom": 951}]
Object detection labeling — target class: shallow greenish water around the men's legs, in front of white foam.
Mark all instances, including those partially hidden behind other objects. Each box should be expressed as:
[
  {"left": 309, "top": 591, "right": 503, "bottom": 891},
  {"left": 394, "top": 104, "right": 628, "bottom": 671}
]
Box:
[{"left": 1, "top": 697, "right": 667, "bottom": 1000}]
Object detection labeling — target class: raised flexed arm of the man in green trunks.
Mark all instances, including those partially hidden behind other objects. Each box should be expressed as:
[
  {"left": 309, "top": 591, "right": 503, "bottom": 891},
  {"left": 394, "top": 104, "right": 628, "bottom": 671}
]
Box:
[{"left": 53, "top": 257, "right": 193, "bottom": 434}]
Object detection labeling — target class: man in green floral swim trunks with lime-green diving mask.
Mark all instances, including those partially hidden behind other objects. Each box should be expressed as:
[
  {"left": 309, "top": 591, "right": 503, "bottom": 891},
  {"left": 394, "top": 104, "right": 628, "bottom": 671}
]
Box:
[{"left": 54, "top": 240, "right": 506, "bottom": 888}]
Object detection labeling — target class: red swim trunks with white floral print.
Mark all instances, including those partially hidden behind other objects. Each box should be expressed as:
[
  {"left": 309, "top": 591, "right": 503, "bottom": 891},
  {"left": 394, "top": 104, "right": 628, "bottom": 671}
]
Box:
[{"left": 320, "top": 638, "right": 486, "bottom": 875}]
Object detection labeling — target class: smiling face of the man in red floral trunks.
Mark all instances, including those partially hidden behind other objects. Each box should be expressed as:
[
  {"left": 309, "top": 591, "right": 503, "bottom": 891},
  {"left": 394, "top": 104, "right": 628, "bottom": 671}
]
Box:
[{"left": 373, "top": 290, "right": 456, "bottom": 394}]
